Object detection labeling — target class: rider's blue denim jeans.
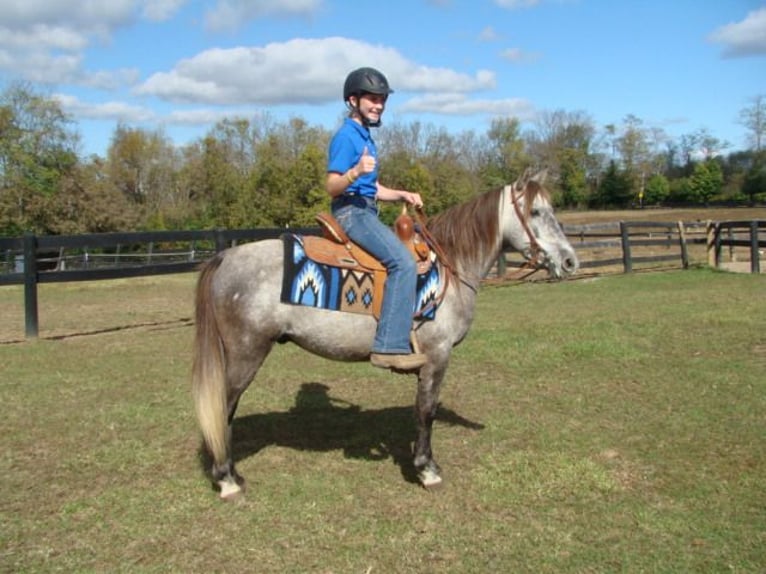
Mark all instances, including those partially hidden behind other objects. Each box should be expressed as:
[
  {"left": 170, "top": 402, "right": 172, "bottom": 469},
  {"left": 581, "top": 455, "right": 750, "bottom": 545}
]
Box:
[{"left": 332, "top": 196, "right": 417, "bottom": 354}]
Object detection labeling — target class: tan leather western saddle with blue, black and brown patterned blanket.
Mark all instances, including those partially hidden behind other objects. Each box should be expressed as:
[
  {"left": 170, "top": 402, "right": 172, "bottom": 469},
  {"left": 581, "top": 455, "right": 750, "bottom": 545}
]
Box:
[{"left": 282, "top": 213, "right": 440, "bottom": 319}]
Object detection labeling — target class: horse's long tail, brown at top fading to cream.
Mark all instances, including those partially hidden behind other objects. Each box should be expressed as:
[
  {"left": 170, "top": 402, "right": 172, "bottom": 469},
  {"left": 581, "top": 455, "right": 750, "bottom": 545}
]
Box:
[{"left": 192, "top": 254, "right": 229, "bottom": 464}]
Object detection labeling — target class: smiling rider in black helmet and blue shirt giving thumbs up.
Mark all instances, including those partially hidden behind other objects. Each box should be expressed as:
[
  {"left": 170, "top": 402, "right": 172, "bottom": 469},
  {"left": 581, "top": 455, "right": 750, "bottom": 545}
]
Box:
[{"left": 325, "top": 68, "right": 426, "bottom": 371}]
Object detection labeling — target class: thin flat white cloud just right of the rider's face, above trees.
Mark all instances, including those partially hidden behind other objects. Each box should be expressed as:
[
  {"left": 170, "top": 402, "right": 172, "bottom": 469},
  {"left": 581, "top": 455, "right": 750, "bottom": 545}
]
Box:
[{"left": 397, "top": 94, "right": 535, "bottom": 121}]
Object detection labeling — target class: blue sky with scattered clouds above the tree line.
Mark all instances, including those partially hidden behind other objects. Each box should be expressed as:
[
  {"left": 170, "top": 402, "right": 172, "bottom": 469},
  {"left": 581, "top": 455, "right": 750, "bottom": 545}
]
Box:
[{"left": 0, "top": 0, "right": 766, "bottom": 156}]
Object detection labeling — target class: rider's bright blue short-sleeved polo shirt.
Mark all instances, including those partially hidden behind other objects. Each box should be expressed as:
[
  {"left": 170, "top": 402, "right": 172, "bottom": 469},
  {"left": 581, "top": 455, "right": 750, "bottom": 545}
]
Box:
[{"left": 327, "top": 118, "right": 378, "bottom": 199}]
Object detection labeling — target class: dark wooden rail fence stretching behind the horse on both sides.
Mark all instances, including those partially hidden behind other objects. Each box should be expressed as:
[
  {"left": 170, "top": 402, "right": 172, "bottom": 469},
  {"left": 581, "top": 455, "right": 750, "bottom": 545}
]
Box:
[{"left": 0, "top": 220, "right": 766, "bottom": 338}]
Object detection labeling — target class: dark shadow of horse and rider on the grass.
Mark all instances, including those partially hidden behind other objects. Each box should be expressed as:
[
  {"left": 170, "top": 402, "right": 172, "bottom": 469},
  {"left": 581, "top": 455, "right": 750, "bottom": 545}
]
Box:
[{"left": 219, "top": 383, "right": 484, "bottom": 483}]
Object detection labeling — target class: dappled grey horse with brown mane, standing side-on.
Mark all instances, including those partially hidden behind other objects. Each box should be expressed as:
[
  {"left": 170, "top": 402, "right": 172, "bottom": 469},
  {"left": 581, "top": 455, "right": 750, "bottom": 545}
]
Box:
[{"left": 192, "top": 173, "right": 579, "bottom": 500}]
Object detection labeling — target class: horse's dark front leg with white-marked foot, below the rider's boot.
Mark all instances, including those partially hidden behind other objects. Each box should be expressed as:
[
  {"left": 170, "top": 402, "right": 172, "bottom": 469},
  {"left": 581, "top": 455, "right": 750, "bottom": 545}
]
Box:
[{"left": 414, "top": 363, "right": 447, "bottom": 488}]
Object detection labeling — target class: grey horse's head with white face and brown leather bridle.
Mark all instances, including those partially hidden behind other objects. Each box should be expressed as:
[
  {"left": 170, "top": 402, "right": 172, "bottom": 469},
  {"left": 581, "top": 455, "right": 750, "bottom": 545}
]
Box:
[{"left": 502, "top": 172, "right": 579, "bottom": 279}]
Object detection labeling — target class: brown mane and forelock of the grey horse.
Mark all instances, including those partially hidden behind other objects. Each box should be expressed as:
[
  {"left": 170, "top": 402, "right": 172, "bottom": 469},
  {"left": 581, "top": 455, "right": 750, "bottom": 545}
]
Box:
[{"left": 427, "top": 180, "right": 548, "bottom": 263}]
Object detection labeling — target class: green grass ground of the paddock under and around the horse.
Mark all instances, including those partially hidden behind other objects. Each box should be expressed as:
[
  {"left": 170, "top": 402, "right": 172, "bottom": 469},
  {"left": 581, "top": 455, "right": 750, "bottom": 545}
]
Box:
[{"left": 0, "top": 269, "right": 766, "bottom": 573}]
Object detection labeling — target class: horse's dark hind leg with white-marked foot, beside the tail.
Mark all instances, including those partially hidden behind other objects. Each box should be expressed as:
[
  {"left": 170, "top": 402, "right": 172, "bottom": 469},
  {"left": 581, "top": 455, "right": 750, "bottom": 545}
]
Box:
[{"left": 212, "top": 343, "right": 272, "bottom": 500}]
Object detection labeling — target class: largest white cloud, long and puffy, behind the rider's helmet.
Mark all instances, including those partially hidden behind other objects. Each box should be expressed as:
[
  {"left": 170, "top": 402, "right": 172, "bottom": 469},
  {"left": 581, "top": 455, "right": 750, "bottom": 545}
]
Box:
[{"left": 135, "top": 37, "right": 495, "bottom": 105}]
